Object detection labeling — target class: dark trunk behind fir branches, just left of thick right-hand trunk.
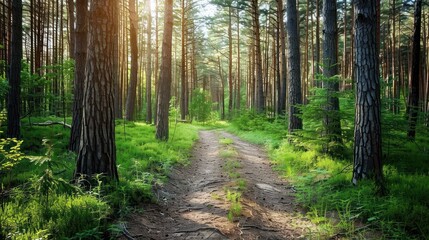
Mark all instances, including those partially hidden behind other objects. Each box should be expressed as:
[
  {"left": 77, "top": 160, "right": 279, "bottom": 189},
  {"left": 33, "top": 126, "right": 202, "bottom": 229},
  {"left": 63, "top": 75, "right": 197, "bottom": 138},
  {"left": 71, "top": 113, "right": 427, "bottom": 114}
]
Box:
[{"left": 322, "top": 0, "right": 341, "bottom": 146}]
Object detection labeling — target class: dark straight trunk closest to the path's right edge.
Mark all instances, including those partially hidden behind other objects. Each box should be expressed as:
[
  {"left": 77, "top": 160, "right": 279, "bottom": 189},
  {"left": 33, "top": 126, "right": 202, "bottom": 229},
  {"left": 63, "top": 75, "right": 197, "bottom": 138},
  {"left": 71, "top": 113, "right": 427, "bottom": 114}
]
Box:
[{"left": 286, "top": 0, "right": 302, "bottom": 133}]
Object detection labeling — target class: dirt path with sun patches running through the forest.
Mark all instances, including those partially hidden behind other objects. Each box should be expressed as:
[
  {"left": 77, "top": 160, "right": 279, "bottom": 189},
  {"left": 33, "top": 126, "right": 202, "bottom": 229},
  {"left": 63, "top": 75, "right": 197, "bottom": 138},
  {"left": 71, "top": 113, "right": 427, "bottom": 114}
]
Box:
[{"left": 122, "top": 131, "right": 314, "bottom": 239}]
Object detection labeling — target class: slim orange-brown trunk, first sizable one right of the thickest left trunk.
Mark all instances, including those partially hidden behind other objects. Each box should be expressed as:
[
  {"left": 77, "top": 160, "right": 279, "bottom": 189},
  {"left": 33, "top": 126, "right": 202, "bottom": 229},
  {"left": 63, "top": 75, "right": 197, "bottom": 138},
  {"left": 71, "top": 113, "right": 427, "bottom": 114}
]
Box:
[{"left": 126, "top": 0, "right": 139, "bottom": 121}]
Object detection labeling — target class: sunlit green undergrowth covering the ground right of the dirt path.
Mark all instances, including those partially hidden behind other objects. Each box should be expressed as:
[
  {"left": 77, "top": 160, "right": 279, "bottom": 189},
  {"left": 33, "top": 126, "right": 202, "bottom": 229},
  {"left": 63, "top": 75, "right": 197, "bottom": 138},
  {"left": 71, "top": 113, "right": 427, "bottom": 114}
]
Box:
[{"left": 229, "top": 110, "right": 429, "bottom": 239}]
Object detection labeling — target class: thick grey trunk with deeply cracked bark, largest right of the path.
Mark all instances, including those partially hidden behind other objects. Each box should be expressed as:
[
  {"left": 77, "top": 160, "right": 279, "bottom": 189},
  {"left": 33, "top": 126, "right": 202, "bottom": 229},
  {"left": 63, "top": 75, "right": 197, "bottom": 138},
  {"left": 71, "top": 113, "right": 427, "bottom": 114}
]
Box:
[{"left": 352, "top": 0, "right": 382, "bottom": 191}]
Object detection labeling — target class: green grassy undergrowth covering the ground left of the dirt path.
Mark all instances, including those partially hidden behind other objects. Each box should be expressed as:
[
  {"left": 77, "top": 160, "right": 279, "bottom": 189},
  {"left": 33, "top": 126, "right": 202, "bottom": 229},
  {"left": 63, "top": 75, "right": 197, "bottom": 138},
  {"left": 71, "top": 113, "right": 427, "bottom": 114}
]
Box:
[{"left": 0, "top": 118, "right": 198, "bottom": 239}]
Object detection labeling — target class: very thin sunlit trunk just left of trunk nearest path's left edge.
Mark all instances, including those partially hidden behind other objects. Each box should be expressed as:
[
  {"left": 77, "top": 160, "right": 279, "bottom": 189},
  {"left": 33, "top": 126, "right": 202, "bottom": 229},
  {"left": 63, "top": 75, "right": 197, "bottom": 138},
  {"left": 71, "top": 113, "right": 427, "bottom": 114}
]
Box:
[{"left": 146, "top": 1, "right": 156, "bottom": 124}]
